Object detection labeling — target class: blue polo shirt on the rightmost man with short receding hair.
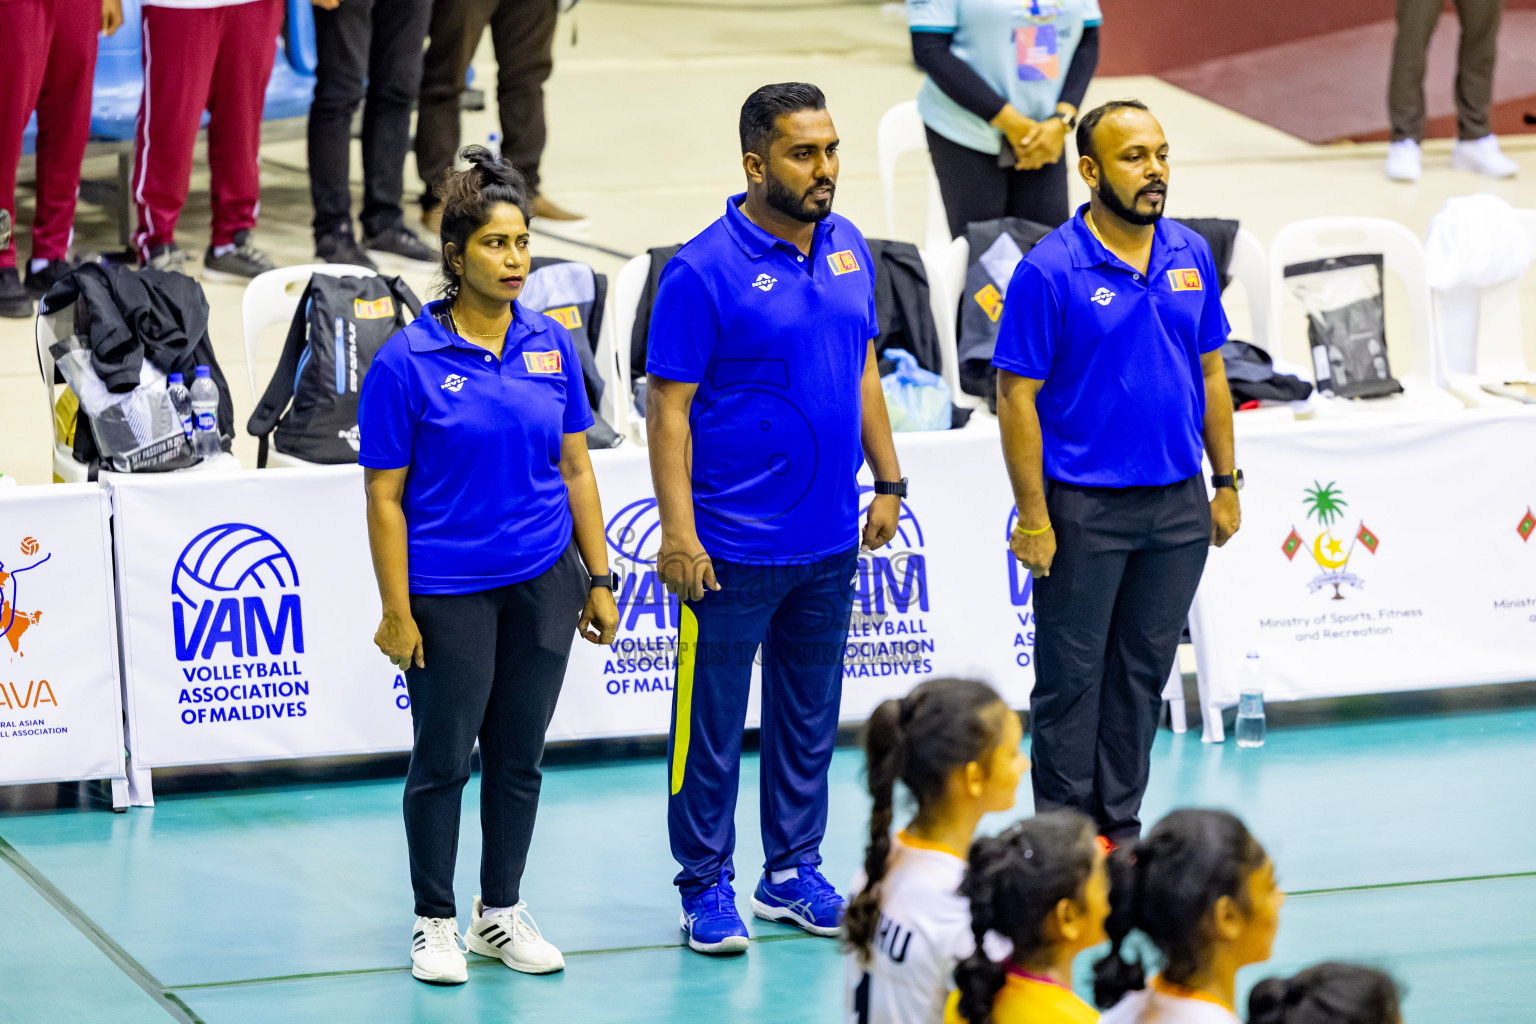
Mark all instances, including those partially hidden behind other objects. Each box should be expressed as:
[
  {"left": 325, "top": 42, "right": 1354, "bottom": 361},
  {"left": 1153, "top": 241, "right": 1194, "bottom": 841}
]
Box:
[{"left": 992, "top": 204, "right": 1230, "bottom": 487}]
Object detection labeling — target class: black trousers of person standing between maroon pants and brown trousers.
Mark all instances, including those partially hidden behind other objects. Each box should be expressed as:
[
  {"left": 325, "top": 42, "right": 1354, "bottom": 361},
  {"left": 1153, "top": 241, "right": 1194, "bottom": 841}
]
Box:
[{"left": 309, "top": 0, "right": 430, "bottom": 238}]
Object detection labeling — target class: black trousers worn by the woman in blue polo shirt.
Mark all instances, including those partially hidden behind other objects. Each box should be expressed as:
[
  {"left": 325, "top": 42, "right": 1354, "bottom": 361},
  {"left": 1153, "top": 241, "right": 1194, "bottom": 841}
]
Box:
[{"left": 399, "top": 540, "right": 587, "bottom": 918}]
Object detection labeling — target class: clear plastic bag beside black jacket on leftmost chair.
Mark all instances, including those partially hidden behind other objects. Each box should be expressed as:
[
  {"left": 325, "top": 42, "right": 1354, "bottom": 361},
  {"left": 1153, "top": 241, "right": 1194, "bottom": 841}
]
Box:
[{"left": 48, "top": 335, "right": 197, "bottom": 473}]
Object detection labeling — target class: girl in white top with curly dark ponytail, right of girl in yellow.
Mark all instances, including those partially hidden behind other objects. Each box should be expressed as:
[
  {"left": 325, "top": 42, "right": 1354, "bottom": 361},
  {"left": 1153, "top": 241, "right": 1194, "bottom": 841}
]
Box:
[{"left": 1094, "top": 811, "right": 1286, "bottom": 1024}]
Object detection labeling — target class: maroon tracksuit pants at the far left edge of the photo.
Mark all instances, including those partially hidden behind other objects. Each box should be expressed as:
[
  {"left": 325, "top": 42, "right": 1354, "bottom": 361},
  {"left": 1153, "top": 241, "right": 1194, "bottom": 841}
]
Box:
[{"left": 0, "top": 0, "right": 101, "bottom": 269}]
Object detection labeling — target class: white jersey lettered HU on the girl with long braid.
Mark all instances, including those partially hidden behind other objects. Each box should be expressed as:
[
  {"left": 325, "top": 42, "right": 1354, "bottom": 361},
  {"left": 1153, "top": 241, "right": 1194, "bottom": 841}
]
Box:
[{"left": 843, "top": 832, "right": 975, "bottom": 1024}]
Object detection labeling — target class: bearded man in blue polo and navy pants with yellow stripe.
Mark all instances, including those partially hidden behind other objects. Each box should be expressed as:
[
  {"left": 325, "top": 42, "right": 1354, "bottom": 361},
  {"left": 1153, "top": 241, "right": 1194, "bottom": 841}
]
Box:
[{"left": 647, "top": 83, "right": 906, "bottom": 953}]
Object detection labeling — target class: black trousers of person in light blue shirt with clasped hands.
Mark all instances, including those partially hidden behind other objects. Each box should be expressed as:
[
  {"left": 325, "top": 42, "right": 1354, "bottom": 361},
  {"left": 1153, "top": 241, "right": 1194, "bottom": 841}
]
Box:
[{"left": 926, "top": 127, "right": 1071, "bottom": 238}]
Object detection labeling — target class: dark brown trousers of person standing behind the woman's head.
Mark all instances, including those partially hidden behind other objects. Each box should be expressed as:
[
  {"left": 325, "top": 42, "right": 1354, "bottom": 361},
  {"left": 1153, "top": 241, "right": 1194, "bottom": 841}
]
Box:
[{"left": 417, "top": 0, "right": 558, "bottom": 209}]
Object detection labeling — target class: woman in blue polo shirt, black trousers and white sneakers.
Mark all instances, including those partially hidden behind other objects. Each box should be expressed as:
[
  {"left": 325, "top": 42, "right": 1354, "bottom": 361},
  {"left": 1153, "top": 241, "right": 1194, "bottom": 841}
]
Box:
[{"left": 358, "top": 147, "right": 619, "bottom": 984}]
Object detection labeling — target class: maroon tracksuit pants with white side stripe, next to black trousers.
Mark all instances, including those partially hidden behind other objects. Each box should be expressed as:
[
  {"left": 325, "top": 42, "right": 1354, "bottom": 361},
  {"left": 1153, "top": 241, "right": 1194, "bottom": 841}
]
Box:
[{"left": 131, "top": 0, "right": 283, "bottom": 263}]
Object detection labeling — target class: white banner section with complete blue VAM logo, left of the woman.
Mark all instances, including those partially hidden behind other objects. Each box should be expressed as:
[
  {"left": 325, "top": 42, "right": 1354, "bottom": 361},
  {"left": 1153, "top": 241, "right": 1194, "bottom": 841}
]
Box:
[{"left": 111, "top": 467, "right": 412, "bottom": 769}]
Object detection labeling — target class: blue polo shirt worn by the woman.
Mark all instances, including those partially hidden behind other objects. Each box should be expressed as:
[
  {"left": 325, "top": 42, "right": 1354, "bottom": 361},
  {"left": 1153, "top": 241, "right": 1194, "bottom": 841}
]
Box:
[{"left": 358, "top": 302, "right": 593, "bottom": 594}]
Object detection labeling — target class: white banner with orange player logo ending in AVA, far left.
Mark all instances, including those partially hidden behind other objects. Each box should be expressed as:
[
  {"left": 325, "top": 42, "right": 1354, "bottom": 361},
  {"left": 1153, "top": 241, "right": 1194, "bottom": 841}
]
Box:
[{"left": 0, "top": 484, "right": 123, "bottom": 783}]
